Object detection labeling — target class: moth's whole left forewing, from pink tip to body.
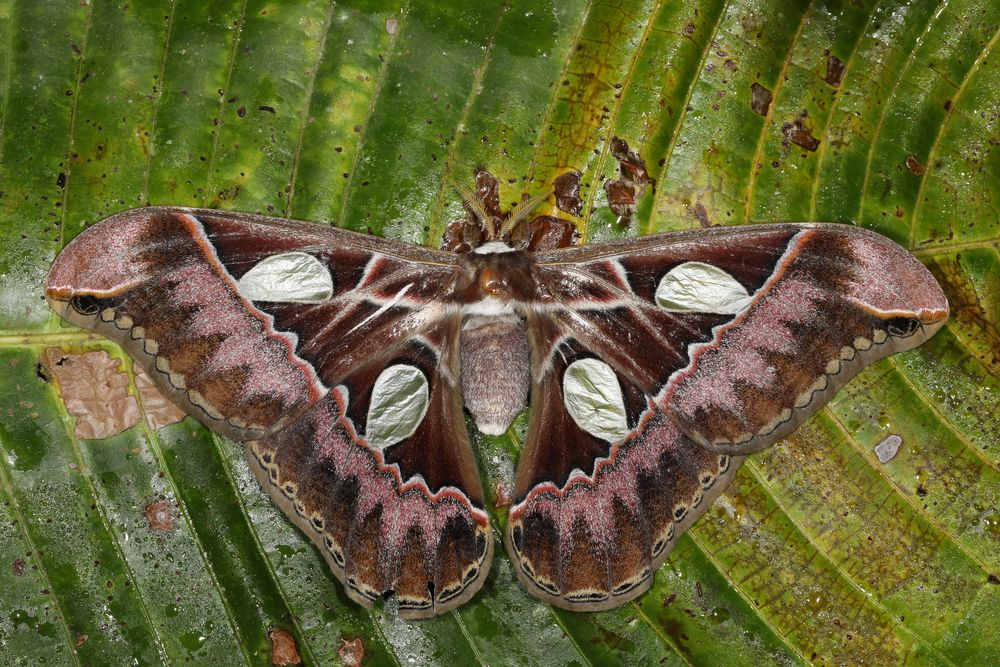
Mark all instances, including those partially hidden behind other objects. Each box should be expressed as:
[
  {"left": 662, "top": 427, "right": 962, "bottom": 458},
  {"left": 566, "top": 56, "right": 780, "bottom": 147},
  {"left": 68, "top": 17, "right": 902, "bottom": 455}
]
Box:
[{"left": 45, "top": 207, "right": 464, "bottom": 439}]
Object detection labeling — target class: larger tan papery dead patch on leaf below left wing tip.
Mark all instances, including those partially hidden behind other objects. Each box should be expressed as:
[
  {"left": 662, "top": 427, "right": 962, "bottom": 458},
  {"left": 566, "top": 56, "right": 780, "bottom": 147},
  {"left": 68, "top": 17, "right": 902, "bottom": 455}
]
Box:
[{"left": 43, "top": 347, "right": 139, "bottom": 440}]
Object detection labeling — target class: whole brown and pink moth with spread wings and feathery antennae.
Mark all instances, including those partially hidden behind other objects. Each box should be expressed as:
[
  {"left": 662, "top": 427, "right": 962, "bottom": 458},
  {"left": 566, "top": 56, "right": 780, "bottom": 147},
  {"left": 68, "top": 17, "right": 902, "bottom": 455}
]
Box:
[{"left": 45, "top": 196, "right": 948, "bottom": 617}]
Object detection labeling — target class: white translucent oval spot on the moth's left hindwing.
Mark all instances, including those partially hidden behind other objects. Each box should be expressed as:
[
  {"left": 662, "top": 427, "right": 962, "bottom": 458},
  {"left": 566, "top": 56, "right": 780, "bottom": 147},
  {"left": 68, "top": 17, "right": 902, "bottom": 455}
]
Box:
[{"left": 365, "top": 364, "right": 430, "bottom": 449}]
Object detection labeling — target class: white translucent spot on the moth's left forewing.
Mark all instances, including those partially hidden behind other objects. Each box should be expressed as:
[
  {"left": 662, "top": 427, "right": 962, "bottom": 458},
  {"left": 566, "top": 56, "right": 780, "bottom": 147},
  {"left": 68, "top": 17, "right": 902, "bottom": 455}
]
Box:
[{"left": 239, "top": 252, "right": 333, "bottom": 302}]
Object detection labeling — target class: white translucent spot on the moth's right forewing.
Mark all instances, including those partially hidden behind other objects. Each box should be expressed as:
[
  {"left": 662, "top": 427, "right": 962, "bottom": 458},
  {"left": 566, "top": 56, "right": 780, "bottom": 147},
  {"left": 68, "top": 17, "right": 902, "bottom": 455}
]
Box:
[{"left": 656, "top": 262, "right": 750, "bottom": 315}]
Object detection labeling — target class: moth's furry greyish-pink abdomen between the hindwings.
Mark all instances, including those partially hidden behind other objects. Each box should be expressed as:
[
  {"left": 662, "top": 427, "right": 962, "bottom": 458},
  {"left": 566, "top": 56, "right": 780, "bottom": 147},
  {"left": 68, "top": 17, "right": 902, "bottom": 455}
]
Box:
[{"left": 461, "top": 316, "right": 531, "bottom": 435}]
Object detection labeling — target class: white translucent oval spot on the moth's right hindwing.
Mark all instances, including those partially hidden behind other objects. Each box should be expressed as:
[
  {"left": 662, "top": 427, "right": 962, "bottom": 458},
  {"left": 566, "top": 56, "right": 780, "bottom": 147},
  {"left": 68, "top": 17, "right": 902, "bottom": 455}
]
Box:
[{"left": 563, "top": 359, "right": 628, "bottom": 442}]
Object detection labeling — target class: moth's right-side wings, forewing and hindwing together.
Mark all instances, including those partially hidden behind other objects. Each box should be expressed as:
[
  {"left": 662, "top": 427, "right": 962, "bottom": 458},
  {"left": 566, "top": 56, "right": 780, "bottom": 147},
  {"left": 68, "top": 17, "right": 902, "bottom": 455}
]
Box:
[{"left": 507, "top": 225, "right": 948, "bottom": 610}]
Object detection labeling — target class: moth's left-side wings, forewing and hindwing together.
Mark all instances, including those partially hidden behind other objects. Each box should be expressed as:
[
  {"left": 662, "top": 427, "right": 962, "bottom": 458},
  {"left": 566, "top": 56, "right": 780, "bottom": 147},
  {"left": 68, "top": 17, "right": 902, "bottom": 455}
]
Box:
[{"left": 46, "top": 208, "right": 492, "bottom": 616}]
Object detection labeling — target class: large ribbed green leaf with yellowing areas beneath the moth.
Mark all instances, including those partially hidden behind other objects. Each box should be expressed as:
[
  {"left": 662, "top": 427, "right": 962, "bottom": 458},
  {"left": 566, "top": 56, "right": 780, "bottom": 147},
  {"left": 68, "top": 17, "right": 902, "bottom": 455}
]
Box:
[{"left": 0, "top": 0, "right": 1000, "bottom": 665}]
